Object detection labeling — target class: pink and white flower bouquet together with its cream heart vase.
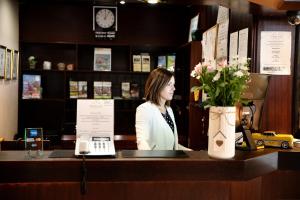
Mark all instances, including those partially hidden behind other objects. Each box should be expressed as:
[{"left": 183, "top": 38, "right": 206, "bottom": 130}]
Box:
[{"left": 191, "top": 59, "right": 250, "bottom": 159}]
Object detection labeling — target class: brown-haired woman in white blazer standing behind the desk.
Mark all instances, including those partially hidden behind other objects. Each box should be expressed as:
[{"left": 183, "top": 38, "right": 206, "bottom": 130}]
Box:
[{"left": 135, "top": 68, "right": 190, "bottom": 150}]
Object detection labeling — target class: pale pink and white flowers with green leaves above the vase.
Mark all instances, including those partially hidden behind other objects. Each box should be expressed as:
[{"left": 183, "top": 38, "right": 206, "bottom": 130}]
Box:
[{"left": 191, "top": 59, "right": 250, "bottom": 107}]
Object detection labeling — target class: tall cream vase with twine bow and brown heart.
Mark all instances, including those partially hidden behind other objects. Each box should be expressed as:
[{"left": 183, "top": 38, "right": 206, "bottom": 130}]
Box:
[{"left": 208, "top": 106, "right": 236, "bottom": 159}]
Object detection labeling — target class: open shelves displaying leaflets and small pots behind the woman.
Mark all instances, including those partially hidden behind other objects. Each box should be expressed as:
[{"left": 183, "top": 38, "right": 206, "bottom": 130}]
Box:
[{"left": 19, "top": 41, "right": 183, "bottom": 141}]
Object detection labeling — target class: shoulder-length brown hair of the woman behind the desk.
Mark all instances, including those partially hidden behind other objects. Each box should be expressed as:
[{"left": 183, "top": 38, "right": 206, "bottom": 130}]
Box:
[{"left": 145, "top": 68, "right": 174, "bottom": 106}]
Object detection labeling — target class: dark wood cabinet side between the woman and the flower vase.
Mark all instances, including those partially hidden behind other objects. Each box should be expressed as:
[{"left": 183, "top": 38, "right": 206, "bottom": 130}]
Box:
[{"left": 176, "top": 41, "right": 208, "bottom": 150}]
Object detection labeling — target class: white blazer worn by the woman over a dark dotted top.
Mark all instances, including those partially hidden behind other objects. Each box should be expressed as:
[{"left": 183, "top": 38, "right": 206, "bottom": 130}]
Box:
[{"left": 135, "top": 101, "right": 190, "bottom": 150}]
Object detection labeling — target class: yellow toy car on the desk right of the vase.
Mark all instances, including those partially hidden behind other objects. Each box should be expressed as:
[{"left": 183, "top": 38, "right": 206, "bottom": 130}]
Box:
[{"left": 252, "top": 131, "right": 294, "bottom": 149}]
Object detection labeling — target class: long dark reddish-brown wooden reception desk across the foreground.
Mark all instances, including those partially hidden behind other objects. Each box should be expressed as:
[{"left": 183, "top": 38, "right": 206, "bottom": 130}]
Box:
[{"left": 0, "top": 149, "right": 300, "bottom": 200}]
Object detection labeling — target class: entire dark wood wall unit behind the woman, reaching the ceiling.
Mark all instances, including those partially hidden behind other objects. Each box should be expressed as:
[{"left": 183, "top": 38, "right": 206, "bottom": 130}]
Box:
[{"left": 18, "top": 1, "right": 208, "bottom": 145}]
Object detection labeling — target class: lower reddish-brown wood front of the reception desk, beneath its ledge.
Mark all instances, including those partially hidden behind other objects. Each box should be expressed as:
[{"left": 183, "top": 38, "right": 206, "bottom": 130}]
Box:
[{"left": 0, "top": 180, "right": 260, "bottom": 200}]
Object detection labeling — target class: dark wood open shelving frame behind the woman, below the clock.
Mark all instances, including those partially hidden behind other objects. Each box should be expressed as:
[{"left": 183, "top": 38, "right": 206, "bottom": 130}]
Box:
[{"left": 19, "top": 42, "right": 182, "bottom": 140}]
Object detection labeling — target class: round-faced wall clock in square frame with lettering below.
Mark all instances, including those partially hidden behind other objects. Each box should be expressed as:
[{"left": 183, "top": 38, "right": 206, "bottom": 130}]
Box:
[{"left": 93, "top": 6, "right": 118, "bottom": 39}]
